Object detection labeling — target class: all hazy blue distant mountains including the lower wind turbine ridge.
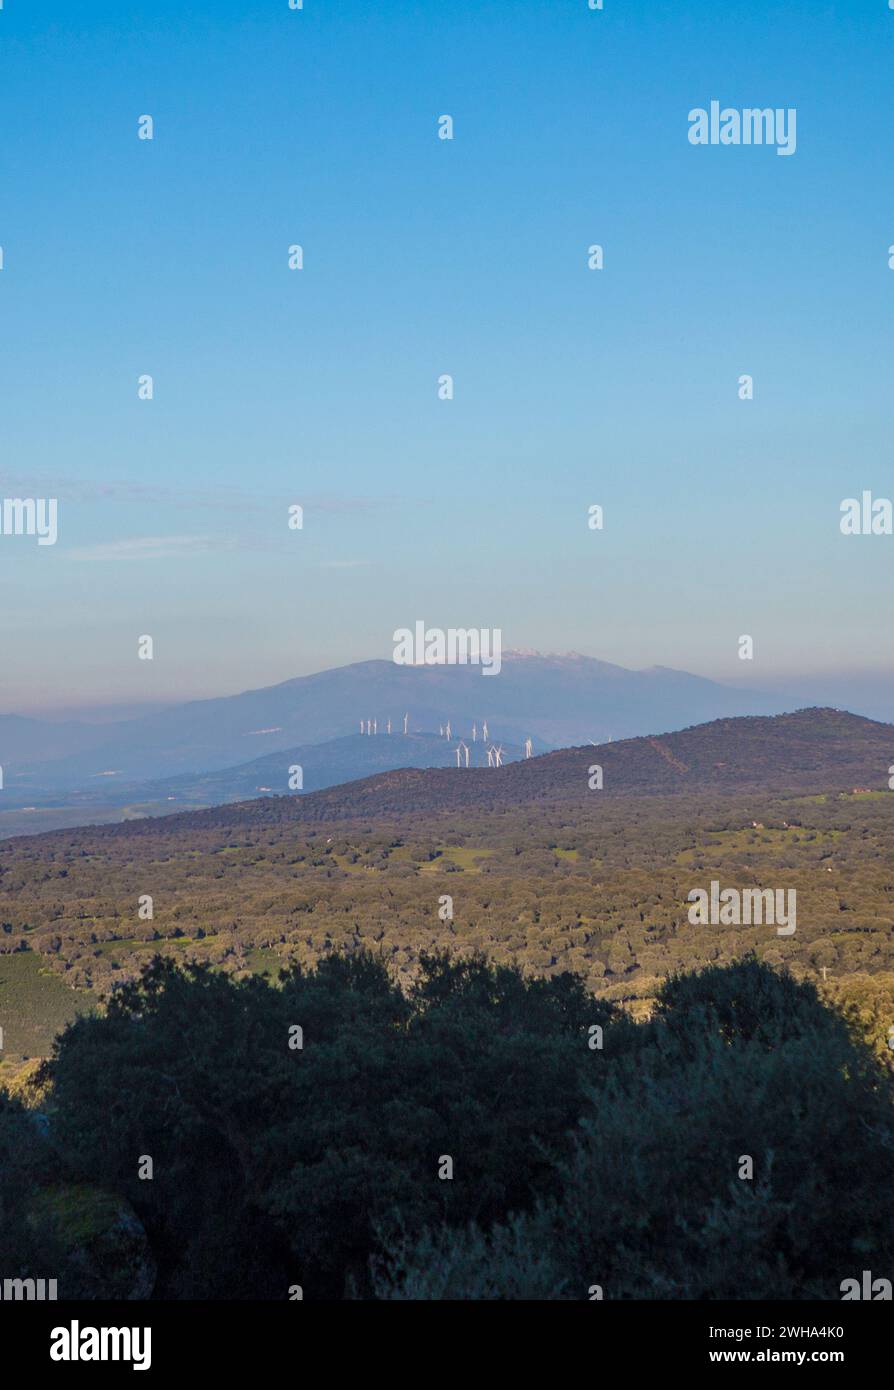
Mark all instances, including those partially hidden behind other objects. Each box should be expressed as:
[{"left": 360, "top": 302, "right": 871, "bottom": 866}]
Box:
[{"left": 19, "top": 652, "right": 894, "bottom": 838}]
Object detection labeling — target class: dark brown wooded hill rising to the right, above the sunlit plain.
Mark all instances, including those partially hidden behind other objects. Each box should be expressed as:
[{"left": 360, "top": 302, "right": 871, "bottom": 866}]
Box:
[{"left": 12, "top": 709, "right": 894, "bottom": 844}]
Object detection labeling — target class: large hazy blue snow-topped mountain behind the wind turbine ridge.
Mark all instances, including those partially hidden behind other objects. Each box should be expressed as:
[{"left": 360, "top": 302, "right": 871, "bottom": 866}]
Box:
[{"left": 0, "top": 653, "right": 793, "bottom": 791}]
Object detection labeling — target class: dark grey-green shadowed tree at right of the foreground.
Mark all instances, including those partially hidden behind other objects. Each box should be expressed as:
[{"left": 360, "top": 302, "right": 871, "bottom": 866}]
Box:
[{"left": 375, "top": 962, "right": 894, "bottom": 1300}]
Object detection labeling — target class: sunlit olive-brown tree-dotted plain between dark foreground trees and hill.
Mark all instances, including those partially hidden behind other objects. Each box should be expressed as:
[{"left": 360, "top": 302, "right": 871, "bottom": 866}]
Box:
[{"left": 0, "top": 783, "right": 894, "bottom": 1034}]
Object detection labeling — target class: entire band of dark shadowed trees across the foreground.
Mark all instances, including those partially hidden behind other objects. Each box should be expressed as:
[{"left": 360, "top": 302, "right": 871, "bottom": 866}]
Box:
[{"left": 0, "top": 951, "right": 894, "bottom": 1300}]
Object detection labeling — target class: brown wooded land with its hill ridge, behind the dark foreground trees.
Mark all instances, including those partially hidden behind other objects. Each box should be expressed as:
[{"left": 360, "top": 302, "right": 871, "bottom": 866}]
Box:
[{"left": 0, "top": 710, "right": 894, "bottom": 1048}]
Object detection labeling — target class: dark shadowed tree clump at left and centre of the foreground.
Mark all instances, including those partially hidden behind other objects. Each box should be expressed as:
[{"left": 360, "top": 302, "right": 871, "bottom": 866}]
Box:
[{"left": 33, "top": 952, "right": 622, "bottom": 1297}]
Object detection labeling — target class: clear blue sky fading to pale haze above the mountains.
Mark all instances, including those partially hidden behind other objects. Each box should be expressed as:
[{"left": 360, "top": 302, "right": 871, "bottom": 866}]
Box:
[{"left": 0, "top": 0, "right": 894, "bottom": 713}]
